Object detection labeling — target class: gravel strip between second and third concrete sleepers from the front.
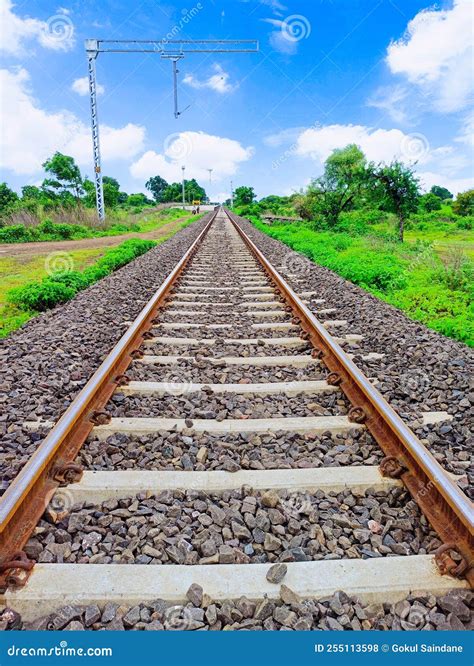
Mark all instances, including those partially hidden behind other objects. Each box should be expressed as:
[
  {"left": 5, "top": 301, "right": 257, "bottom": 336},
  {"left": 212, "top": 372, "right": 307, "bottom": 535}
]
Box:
[{"left": 77, "top": 428, "right": 383, "bottom": 472}]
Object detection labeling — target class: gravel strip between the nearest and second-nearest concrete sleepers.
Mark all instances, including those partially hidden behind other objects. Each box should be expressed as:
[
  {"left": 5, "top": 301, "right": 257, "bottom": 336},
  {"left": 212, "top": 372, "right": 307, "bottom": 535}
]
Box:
[{"left": 25, "top": 486, "right": 441, "bottom": 565}]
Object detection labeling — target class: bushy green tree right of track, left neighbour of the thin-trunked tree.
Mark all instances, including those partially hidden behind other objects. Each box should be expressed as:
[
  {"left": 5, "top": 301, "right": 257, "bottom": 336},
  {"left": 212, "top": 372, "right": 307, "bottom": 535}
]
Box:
[{"left": 295, "top": 144, "right": 367, "bottom": 226}]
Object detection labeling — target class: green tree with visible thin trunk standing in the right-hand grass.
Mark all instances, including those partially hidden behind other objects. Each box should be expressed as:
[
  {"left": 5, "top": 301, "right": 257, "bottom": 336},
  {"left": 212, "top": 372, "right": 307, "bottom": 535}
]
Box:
[{"left": 369, "top": 161, "right": 420, "bottom": 243}]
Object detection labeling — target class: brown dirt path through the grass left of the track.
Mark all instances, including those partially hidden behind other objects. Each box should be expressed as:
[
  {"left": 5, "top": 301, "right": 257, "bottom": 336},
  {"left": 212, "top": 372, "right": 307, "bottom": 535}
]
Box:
[{"left": 0, "top": 217, "right": 186, "bottom": 258}]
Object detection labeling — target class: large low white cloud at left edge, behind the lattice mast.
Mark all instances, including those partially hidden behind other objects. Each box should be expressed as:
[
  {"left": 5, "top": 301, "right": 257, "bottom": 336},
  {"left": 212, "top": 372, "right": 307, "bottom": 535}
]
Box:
[{"left": 0, "top": 69, "right": 145, "bottom": 175}]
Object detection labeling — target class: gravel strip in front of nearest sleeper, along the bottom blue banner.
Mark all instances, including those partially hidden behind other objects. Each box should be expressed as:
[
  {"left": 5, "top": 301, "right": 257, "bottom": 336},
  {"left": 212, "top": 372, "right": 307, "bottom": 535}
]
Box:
[{"left": 0, "top": 584, "right": 474, "bottom": 631}]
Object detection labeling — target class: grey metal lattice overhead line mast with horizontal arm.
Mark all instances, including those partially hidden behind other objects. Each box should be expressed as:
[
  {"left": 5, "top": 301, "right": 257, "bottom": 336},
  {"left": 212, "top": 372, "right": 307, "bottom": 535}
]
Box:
[{"left": 85, "top": 39, "right": 259, "bottom": 221}]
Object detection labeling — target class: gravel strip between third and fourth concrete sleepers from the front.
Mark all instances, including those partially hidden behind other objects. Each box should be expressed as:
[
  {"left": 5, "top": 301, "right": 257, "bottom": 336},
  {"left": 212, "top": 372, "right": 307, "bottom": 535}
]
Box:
[{"left": 106, "top": 391, "right": 350, "bottom": 421}]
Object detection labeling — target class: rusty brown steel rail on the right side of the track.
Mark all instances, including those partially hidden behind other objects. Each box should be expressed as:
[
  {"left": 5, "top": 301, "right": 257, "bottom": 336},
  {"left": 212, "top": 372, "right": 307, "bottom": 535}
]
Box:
[{"left": 226, "top": 210, "right": 474, "bottom": 585}]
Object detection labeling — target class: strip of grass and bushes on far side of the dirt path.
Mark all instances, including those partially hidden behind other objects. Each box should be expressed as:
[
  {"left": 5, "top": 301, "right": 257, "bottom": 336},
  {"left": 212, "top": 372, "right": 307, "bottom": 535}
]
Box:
[{"left": 0, "top": 208, "right": 196, "bottom": 243}]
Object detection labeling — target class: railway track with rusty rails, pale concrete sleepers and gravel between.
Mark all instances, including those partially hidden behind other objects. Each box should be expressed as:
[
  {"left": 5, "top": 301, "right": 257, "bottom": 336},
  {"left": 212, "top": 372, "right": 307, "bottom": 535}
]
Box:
[{"left": 0, "top": 209, "right": 474, "bottom": 630}]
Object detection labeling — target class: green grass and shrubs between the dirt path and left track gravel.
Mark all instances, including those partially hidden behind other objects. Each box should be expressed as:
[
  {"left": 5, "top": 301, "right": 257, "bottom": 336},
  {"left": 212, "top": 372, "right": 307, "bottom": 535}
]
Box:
[{"left": 0, "top": 210, "right": 202, "bottom": 338}]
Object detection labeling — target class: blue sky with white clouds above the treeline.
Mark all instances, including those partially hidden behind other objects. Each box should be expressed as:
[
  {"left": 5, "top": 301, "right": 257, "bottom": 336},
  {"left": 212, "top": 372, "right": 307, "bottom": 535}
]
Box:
[{"left": 0, "top": 0, "right": 474, "bottom": 199}]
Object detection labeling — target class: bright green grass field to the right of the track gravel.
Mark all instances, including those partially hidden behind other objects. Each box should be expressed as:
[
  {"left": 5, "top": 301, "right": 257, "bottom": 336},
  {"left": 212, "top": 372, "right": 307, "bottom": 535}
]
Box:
[{"left": 252, "top": 218, "right": 474, "bottom": 346}]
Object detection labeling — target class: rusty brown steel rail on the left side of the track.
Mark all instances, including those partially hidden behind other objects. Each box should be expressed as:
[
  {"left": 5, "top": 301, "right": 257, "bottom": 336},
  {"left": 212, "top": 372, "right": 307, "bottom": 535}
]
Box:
[{"left": 0, "top": 211, "right": 217, "bottom": 587}]
